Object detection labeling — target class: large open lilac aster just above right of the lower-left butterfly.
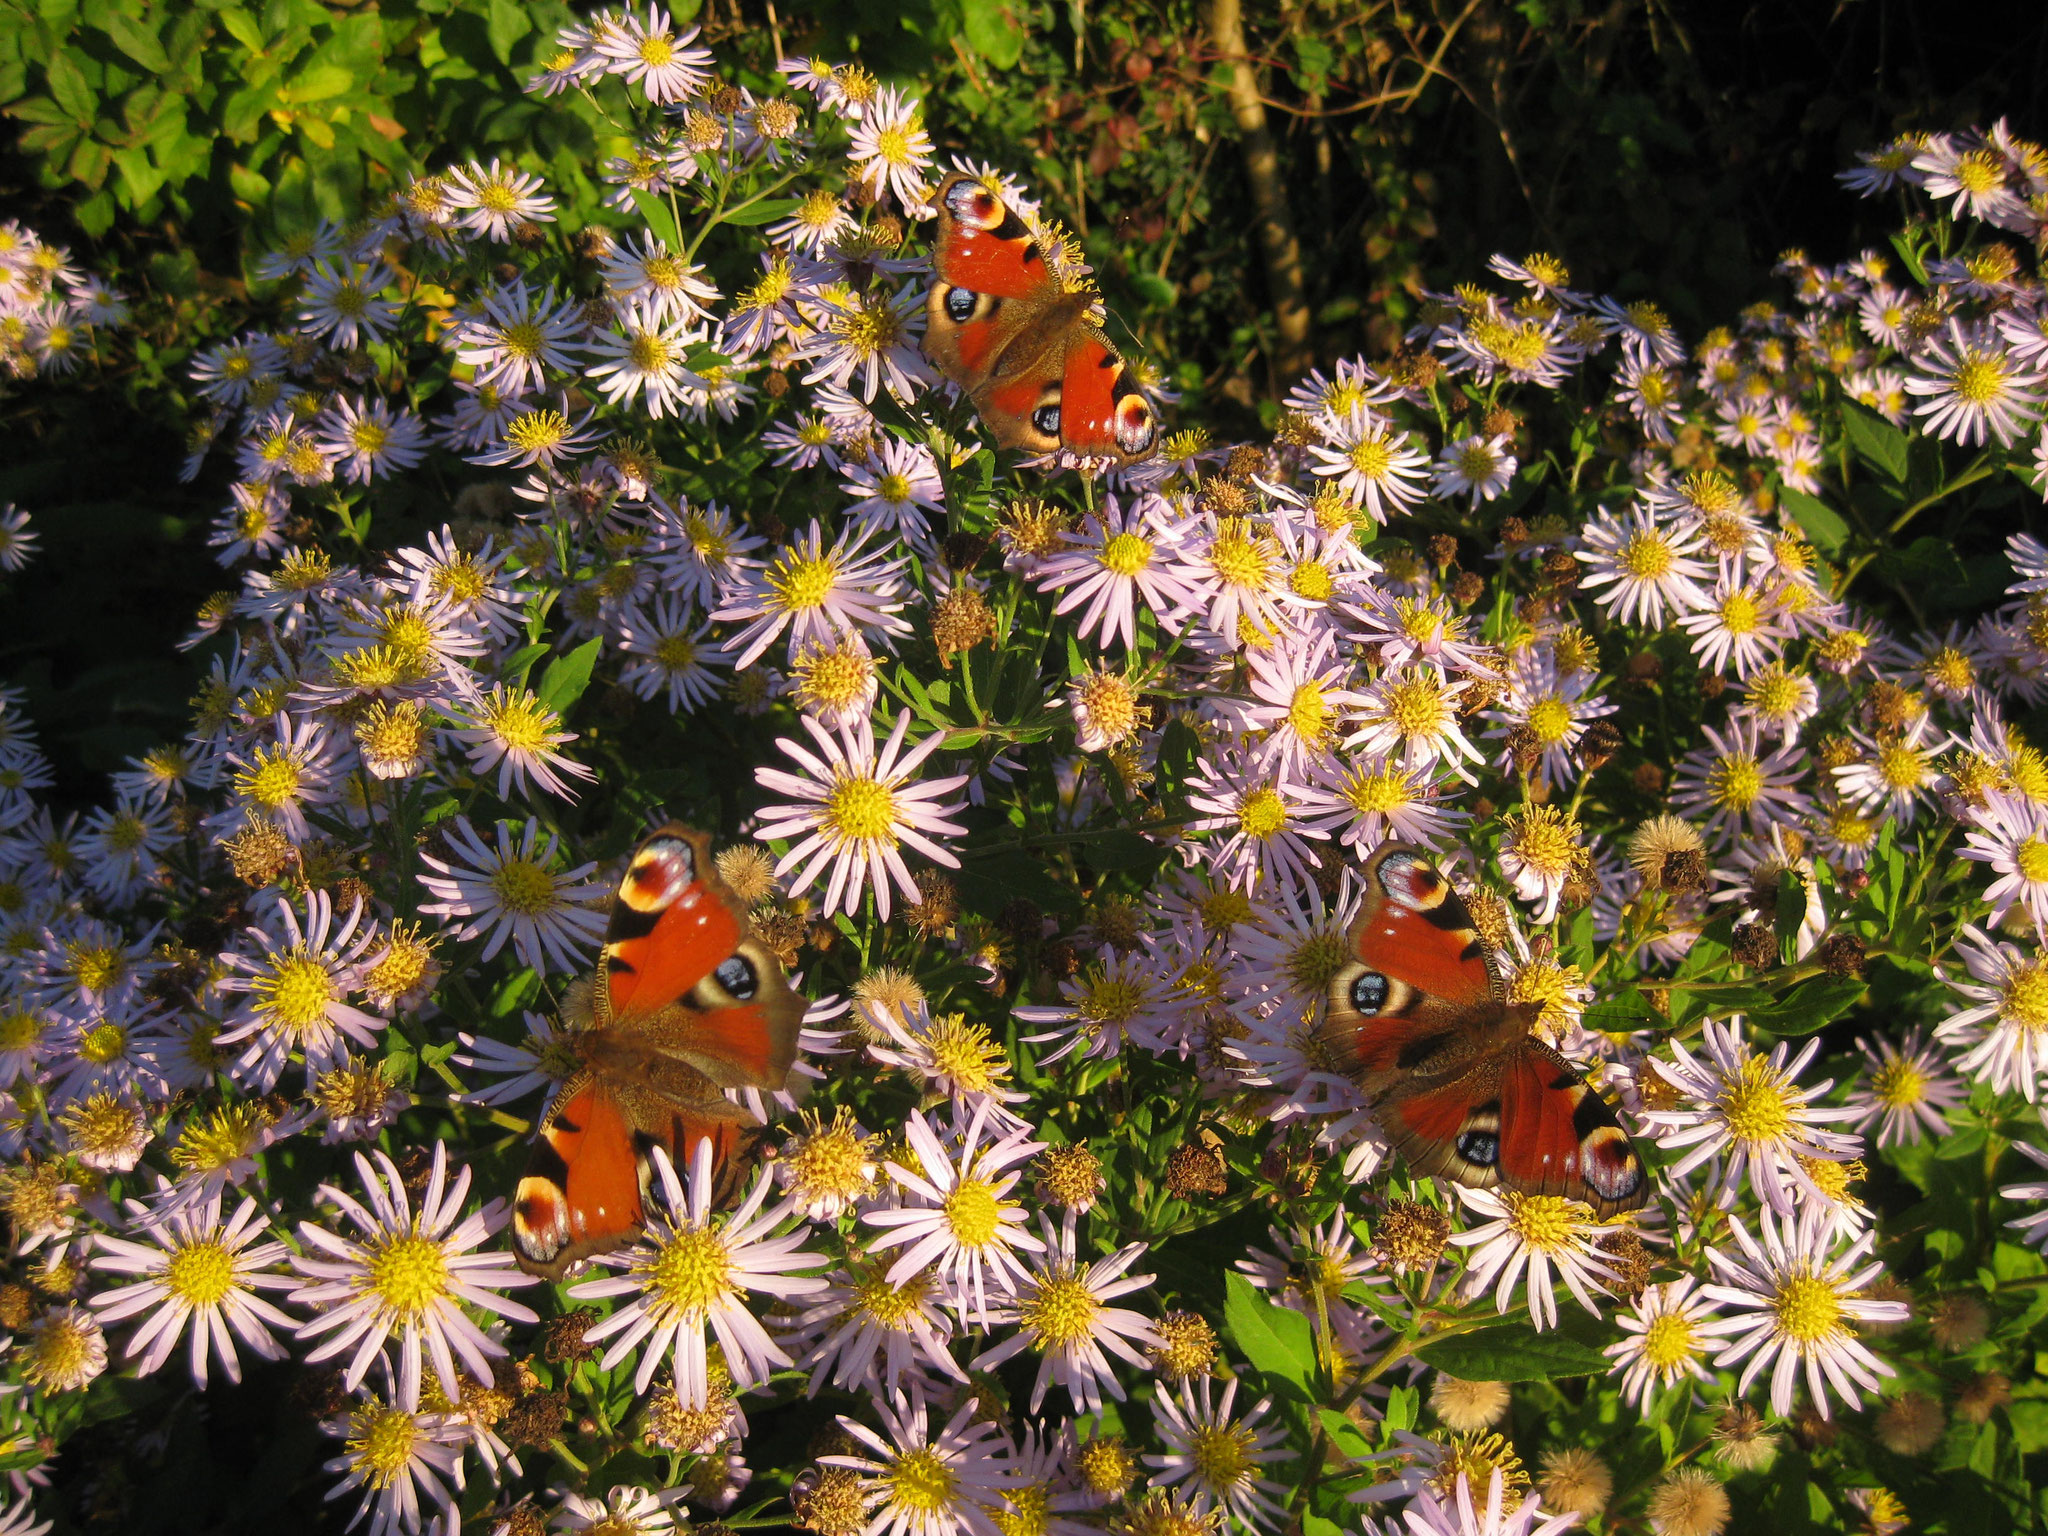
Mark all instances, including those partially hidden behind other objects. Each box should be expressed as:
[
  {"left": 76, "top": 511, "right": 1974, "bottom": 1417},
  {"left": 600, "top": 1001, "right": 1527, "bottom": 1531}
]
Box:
[{"left": 754, "top": 711, "right": 967, "bottom": 920}]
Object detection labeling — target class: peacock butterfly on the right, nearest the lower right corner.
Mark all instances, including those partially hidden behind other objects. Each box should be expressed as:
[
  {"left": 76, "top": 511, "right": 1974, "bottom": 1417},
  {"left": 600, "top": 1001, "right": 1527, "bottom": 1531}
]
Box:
[{"left": 1323, "top": 842, "right": 1649, "bottom": 1217}]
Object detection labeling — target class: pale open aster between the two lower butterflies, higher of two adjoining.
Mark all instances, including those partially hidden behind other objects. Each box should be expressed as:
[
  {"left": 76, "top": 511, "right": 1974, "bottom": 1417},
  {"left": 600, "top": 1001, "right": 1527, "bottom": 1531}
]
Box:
[{"left": 862, "top": 1098, "right": 1044, "bottom": 1323}]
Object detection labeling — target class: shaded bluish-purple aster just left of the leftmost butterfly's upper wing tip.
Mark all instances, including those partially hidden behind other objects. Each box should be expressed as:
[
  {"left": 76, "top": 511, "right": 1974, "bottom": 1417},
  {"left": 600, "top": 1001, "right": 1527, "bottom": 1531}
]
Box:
[{"left": 420, "top": 815, "right": 612, "bottom": 973}]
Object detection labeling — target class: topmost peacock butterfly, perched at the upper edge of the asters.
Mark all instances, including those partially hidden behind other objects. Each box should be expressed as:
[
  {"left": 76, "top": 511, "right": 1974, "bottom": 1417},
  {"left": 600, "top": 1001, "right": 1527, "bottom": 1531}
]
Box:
[{"left": 924, "top": 172, "right": 1159, "bottom": 465}]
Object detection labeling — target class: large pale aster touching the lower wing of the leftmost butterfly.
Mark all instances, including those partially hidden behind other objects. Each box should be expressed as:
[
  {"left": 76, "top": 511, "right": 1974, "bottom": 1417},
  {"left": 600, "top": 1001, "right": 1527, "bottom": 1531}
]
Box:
[{"left": 569, "top": 1137, "right": 825, "bottom": 1409}]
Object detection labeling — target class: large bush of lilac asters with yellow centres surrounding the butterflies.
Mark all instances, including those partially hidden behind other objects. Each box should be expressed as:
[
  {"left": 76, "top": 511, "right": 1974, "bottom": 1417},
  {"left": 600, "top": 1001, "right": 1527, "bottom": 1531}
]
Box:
[{"left": 0, "top": 18, "right": 2048, "bottom": 1536}]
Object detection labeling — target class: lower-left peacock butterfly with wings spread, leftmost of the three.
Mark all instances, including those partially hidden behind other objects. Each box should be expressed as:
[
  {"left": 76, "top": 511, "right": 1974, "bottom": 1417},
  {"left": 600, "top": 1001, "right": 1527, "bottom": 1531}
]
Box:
[{"left": 512, "top": 825, "right": 803, "bottom": 1280}]
